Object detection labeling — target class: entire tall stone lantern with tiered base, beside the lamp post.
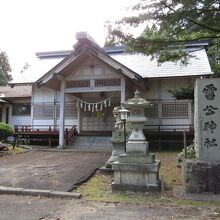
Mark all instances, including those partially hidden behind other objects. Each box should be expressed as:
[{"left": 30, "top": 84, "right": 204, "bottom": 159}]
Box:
[{"left": 112, "top": 91, "right": 160, "bottom": 192}]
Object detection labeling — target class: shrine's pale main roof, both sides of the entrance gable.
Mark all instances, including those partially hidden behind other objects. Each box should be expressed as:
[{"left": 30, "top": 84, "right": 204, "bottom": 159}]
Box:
[{"left": 13, "top": 46, "right": 212, "bottom": 83}]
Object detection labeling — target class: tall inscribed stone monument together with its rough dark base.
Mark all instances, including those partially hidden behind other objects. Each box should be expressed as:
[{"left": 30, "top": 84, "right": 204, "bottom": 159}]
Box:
[{"left": 183, "top": 79, "right": 220, "bottom": 193}]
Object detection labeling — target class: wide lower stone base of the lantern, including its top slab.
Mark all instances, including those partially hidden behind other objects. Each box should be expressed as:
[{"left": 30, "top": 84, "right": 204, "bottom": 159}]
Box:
[{"left": 112, "top": 154, "right": 160, "bottom": 192}]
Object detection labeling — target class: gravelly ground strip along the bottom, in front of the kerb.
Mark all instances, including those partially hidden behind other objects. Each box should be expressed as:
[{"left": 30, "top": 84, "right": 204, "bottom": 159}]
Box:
[{"left": 0, "top": 195, "right": 220, "bottom": 220}]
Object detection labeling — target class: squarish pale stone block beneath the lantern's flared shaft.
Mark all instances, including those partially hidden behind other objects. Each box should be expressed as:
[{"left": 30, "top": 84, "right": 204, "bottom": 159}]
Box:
[{"left": 126, "top": 141, "right": 149, "bottom": 156}]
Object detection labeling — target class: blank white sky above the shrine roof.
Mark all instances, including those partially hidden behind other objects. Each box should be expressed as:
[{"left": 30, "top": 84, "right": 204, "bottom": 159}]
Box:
[{"left": 0, "top": 0, "right": 134, "bottom": 81}]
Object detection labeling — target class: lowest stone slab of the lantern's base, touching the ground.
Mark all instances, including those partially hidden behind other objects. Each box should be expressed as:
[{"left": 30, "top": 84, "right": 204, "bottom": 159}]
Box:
[{"left": 112, "top": 182, "right": 160, "bottom": 192}]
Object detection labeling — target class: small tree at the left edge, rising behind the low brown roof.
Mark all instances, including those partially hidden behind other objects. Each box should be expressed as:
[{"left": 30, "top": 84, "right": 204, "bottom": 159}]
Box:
[{"left": 0, "top": 51, "right": 12, "bottom": 86}]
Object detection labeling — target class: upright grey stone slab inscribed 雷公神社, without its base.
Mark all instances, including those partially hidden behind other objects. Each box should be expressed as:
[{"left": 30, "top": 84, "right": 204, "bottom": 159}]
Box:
[{"left": 194, "top": 79, "right": 220, "bottom": 163}]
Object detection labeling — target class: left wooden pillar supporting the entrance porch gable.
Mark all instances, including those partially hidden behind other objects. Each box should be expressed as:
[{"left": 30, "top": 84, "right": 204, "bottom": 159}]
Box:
[{"left": 58, "top": 78, "right": 66, "bottom": 148}]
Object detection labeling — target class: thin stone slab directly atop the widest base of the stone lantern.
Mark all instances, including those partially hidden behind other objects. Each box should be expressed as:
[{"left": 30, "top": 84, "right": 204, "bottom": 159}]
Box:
[{"left": 119, "top": 153, "right": 155, "bottom": 164}]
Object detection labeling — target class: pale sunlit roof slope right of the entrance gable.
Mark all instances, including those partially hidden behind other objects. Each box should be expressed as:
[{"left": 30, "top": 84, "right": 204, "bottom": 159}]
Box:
[{"left": 111, "top": 49, "right": 212, "bottom": 78}]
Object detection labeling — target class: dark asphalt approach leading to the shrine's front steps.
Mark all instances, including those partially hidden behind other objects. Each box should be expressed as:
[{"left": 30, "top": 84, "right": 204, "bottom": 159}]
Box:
[{"left": 0, "top": 151, "right": 109, "bottom": 191}]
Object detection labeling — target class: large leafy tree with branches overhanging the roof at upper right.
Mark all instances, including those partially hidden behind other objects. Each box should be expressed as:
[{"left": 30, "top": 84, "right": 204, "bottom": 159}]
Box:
[{"left": 106, "top": 0, "right": 220, "bottom": 77}]
